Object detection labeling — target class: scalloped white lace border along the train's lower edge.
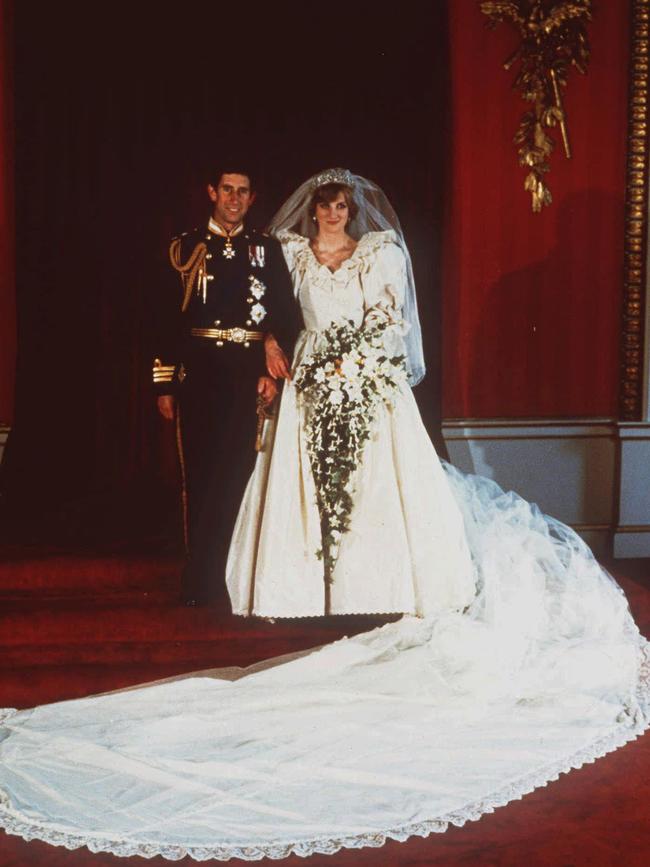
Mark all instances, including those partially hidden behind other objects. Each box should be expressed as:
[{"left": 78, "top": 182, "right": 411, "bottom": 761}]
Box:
[{"left": 0, "top": 684, "right": 650, "bottom": 861}]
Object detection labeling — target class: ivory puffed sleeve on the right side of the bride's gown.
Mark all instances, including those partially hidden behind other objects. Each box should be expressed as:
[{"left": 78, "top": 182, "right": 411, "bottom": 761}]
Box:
[{"left": 362, "top": 232, "right": 406, "bottom": 322}]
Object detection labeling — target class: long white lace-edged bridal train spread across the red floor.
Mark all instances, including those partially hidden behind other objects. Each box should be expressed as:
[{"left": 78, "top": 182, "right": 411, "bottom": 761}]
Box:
[{"left": 0, "top": 467, "right": 650, "bottom": 860}]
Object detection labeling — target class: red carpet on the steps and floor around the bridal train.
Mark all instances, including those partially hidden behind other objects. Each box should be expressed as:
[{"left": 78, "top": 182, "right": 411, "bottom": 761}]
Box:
[{"left": 0, "top": 550, "right": 650, "bottom": 867}]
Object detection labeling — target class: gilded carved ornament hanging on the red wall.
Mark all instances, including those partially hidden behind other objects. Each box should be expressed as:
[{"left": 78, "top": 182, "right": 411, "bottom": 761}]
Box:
[{"left": 480, "top": 0, "right": 592, "bottom": 212}]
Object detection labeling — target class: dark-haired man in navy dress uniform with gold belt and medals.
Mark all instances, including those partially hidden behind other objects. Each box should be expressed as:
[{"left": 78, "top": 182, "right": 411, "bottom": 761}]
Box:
[{"left": 153, "top": 165, "right": 300, "bottom": 605}]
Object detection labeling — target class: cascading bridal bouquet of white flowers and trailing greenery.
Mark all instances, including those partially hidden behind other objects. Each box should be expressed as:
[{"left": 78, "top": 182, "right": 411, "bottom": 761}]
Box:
[{"left": 294, "top": 321, "right": 406, "bottom": 583}]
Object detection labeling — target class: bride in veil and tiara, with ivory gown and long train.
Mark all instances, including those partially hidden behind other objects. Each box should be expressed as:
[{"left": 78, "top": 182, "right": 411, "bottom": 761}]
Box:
[{"left": 0, "top": 170, "right": 650, "bottom": 861}]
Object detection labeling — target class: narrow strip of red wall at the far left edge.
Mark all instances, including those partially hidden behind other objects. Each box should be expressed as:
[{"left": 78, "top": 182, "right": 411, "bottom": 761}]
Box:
[{"left": 0, "top": 0, "right": 16, "bottom": 424}]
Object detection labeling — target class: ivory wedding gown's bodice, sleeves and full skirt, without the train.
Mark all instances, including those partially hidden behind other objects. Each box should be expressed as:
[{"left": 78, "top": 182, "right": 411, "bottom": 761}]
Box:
[{"left": 227, "top": 231, "right": 475, "bottom": 617}]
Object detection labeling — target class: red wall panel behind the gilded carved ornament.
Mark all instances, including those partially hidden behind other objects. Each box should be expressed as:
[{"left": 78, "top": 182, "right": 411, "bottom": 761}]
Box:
[{"left": 443, "top": 0, "right": 630, "bottom": 418}]
